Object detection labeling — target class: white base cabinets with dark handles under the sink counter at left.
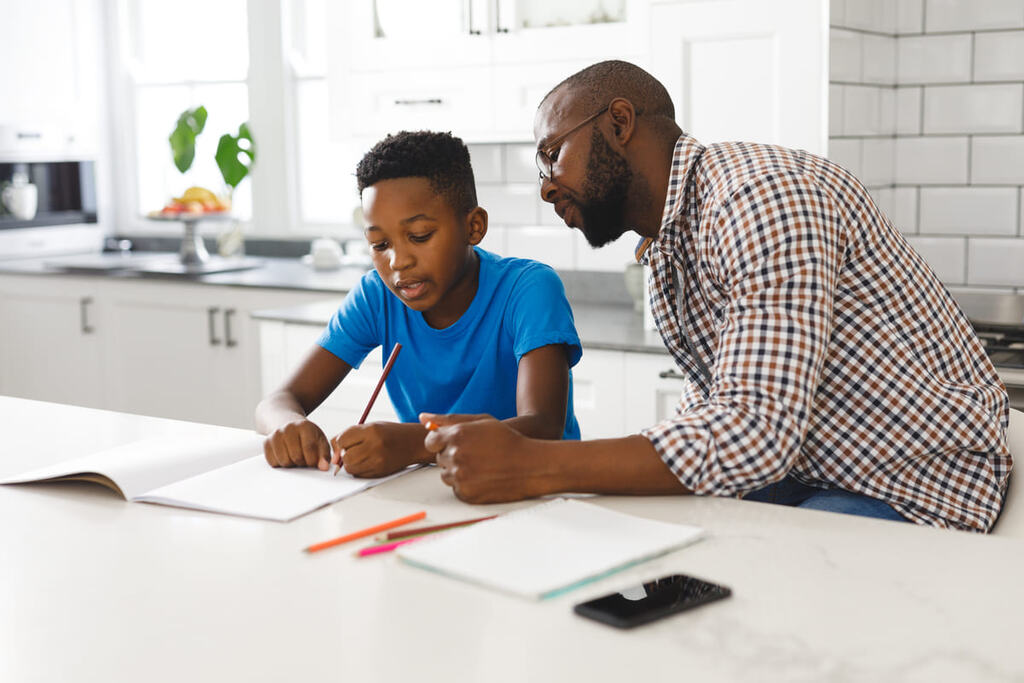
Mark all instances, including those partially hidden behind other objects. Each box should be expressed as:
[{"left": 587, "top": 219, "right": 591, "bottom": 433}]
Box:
[{"left": 0, "top": 275, "right": 342, "bottom": 428}]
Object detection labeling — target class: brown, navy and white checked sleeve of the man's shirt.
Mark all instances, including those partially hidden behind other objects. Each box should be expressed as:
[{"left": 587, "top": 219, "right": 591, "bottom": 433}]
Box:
[{"left": 642, "top": 173, "right": 847, "bottom": 496}]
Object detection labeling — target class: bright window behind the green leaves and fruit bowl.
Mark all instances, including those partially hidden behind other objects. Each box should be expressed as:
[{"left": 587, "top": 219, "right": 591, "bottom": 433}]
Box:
[{"left": 115, "top": 0, "right": 252, "bottom": 224}]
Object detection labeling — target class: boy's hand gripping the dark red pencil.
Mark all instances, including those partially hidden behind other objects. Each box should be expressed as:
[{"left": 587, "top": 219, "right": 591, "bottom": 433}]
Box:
[{"left": 331, "top": 422, "right": 433, "bottom": 478}]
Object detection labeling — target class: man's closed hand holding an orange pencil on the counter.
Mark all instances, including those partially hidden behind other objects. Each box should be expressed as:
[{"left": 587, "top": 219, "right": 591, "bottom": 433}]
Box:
[{"left": 420, "top": 413, "right": 550, "bottom": 503}]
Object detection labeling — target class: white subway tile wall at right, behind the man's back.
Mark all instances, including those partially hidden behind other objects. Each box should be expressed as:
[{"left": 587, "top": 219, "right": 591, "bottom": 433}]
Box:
[{"left": 829, "top": 0, "right": 1024, "bottom": 292}]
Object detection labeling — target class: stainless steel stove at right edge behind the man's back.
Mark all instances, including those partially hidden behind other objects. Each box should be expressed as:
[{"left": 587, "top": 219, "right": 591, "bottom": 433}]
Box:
[{"left": 954, "top": 292, "right": 1024, "bottom": 411}]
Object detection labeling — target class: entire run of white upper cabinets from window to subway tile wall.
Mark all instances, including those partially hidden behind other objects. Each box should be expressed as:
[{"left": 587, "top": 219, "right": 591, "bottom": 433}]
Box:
[{"left": 328, "top": 0, "right": 828, "bottom": 154}]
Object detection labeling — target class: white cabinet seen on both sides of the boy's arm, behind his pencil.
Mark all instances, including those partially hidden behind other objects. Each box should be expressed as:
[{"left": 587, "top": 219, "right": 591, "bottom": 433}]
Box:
[{"left": 259, "top": 321, "right": 398, "bottom": 435}]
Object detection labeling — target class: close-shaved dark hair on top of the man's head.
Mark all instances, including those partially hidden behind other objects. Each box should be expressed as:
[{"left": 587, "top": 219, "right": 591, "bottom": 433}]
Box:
[{"left": 540, "top": 59, "right": 676, "bottom": 119}]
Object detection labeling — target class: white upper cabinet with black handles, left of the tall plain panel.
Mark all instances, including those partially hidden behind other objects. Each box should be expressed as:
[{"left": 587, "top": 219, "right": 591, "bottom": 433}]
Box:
[{"left": 329, "top": 0, "right": 649, "bottom": 142}]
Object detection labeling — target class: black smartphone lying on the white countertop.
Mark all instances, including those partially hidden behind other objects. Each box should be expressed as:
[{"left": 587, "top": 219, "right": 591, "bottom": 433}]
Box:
[{"left": 572, "top": 573, "right": 732, "bottom": 629}]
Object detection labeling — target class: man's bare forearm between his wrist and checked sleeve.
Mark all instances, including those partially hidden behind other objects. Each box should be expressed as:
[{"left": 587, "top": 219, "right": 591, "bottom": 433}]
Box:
[{"left": 530, "top": 435, "right": 691, "bottom": 496}]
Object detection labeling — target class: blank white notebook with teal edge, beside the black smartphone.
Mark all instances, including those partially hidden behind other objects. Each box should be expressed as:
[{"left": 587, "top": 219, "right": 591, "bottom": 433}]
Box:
[{"left": 396, "top": 499, "right": 703, "bottom": 599}]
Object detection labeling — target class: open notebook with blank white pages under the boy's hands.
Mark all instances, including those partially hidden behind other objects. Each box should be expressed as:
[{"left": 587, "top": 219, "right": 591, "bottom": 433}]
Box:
[{"left": 0, "top": 430, "right": 412, "bottom": 521}]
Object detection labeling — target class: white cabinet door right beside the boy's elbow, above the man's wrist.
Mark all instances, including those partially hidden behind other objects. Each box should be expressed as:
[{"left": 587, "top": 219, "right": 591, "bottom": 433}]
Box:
[{"left": 572, "top": 348, "right": 626, "bottom": 438}]
